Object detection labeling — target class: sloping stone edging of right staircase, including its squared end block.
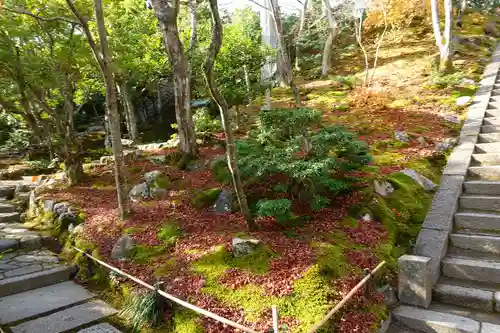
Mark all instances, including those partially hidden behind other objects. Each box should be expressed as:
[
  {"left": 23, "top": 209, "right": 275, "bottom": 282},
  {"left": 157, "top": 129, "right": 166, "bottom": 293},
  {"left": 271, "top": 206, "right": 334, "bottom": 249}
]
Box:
[{"left": 398, "top": 44, "right": 500, "bottom": 307}]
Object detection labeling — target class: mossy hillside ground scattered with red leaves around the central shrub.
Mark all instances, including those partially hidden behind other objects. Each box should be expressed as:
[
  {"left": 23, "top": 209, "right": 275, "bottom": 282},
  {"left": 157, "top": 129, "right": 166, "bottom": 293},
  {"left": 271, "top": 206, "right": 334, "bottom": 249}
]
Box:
[{"left": 36, "top": 11, "right": 500, "bottom": 333}]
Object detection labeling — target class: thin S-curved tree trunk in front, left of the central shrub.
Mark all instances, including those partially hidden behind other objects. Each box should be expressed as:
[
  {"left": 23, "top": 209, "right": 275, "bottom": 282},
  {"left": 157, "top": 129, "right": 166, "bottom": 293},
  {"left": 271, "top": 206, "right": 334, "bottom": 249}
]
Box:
[{"left": 204, "top": 0, "right": 256, "bottom": 230}]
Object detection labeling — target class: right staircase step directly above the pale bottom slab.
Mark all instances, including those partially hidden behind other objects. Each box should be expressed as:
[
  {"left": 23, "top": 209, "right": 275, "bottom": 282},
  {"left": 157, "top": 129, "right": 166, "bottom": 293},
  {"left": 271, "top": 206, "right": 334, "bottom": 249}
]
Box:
[{"left": 433, "top": 279, "right": 497, "bottom": 312}]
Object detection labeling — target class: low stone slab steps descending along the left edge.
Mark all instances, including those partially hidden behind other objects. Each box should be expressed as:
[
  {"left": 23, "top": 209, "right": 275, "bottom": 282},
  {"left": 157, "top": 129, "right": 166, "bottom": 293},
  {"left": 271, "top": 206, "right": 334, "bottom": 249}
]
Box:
[{"left": 0, "top": 181, "right": 124, "bottom": 333}]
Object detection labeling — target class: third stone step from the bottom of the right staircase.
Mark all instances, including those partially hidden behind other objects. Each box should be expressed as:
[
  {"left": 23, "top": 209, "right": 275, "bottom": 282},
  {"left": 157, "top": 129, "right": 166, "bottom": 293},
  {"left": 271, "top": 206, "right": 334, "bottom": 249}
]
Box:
[{"left": 441, "top": 255, "right": 500, "bottom": 283}]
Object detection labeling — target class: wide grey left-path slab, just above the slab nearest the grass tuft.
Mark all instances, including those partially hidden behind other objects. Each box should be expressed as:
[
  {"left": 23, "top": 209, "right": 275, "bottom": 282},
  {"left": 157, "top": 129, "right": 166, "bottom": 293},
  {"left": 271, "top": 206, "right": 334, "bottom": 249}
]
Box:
[{"left": 0, "top": 281, "right": 94, "bottom": 325}]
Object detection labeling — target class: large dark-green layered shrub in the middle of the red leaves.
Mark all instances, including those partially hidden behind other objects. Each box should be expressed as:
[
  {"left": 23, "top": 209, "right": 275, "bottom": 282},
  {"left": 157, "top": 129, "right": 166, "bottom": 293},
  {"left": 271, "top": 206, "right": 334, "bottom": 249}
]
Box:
[{"left": 236, "top": 108, "right": 371, "bottom": 217}]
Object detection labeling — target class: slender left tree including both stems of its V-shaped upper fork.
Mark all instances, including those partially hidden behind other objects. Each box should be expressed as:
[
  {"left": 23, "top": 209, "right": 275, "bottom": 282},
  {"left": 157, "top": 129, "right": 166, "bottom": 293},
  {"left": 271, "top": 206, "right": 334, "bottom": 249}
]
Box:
[{"left": 66, "top": 0, "right": 130, "bottom": 219}]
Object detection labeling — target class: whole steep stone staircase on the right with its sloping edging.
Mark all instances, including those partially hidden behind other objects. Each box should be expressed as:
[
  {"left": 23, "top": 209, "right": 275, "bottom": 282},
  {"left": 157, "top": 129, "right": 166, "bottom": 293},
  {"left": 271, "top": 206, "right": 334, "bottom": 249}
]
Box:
[{"left": 389, "top": 47, "right": 500, "bottom": 333}]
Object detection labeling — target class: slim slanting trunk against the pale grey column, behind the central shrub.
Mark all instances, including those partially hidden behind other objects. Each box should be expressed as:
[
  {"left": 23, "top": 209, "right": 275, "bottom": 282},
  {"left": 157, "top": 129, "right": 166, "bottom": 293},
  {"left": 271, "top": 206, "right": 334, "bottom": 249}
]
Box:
[{"left": 269, "top": 0, "right": 300, "bottom": 107}]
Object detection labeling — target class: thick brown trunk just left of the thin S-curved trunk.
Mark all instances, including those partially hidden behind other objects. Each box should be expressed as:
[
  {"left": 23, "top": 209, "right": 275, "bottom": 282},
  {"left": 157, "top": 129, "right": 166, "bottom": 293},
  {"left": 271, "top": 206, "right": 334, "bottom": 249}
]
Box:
[{"left": 152, "top": 0, "right": 198, "bottom": 156}]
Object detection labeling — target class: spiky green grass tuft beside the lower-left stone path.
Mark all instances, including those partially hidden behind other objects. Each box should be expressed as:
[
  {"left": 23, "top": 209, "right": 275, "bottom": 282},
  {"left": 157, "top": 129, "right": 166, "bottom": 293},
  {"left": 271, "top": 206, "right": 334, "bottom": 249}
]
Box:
[{"left": 120, "top": 291, "right": 163, "bottom": 332}]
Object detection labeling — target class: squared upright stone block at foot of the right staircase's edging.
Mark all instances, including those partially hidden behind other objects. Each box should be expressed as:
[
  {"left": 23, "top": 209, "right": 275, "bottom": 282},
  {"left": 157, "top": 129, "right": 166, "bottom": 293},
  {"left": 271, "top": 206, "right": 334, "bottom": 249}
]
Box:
[{"left": 398, "top": 255, "right": 433, "bottom": 308}]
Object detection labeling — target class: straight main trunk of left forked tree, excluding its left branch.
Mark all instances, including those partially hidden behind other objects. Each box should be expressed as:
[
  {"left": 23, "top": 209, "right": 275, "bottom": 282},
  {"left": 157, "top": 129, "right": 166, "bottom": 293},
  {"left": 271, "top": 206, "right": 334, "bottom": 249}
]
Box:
[{"left": 94, "top": 0, "right": 130, "bottom": 219}]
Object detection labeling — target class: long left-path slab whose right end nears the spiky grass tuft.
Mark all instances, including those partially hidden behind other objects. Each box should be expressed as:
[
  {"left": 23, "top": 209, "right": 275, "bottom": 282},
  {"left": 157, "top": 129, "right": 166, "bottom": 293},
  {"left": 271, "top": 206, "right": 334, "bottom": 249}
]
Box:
[{"left": 11, "top": 300, "right": 118, "bottom": 333}]
